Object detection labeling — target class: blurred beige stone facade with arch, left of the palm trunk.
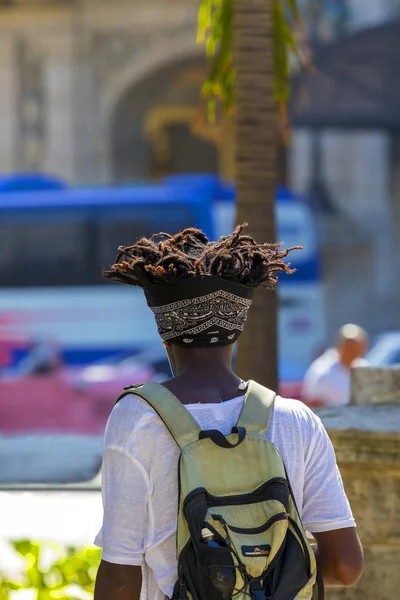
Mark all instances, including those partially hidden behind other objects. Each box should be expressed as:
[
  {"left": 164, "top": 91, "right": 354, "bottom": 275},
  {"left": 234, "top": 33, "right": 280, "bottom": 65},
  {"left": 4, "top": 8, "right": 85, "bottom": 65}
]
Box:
[{"left": 0, "top": 0, "right": 219, "bottom": 182}]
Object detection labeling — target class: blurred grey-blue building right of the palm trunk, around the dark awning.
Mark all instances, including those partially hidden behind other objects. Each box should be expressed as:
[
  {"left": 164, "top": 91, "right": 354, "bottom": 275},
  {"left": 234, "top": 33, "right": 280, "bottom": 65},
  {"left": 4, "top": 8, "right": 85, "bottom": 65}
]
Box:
[{"left": 290, "top": 0, "right": 400, "bottom": 336}]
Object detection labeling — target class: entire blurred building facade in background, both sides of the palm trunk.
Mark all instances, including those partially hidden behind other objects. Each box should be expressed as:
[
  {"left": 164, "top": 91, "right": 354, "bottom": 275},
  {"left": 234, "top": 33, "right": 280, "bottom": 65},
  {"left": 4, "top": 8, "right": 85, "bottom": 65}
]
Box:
[{"left": 0, "top": 0, "right": 400, "bottom": 344}]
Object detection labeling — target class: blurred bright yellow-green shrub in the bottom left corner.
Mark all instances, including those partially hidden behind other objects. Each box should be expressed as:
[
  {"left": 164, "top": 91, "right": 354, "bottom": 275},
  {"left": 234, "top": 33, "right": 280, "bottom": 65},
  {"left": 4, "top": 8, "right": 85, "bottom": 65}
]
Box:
[{"left": 0, "top": 540, "right": 100, "bottom": 600}]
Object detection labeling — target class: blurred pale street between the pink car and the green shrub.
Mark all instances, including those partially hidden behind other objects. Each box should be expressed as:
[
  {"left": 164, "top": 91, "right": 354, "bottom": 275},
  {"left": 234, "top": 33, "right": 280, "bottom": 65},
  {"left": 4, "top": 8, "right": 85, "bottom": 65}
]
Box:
[{"left": 0, "top": 435, "right": 103, "bottom": 572}]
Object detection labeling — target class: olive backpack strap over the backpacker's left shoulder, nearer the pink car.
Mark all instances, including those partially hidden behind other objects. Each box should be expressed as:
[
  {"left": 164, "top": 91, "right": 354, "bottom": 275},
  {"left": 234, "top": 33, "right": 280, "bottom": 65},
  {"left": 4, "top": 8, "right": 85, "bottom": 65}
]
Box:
[{"left": 117, "top": 382, "right": 200, "bottom": 450}]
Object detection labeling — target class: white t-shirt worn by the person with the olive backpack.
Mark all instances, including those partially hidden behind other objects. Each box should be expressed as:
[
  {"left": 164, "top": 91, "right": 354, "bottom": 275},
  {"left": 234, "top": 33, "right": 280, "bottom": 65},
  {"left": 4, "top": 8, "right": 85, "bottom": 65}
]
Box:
[{"left": 95, "top": 395, "right": 354, "bottom": 600}]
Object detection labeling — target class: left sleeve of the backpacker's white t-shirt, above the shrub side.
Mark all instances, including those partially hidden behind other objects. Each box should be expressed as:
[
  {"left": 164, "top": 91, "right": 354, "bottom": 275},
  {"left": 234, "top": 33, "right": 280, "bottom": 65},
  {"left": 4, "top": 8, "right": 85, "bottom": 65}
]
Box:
[{"left": 95, "top": 406, "right": 150, "bottom": 566}]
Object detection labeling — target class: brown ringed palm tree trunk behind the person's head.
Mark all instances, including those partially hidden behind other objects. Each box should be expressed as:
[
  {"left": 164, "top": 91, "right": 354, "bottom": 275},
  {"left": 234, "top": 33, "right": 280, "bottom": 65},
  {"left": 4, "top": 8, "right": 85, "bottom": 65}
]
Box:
[{"left": 233, "top": 0, "right": 277, "bottom": 389}]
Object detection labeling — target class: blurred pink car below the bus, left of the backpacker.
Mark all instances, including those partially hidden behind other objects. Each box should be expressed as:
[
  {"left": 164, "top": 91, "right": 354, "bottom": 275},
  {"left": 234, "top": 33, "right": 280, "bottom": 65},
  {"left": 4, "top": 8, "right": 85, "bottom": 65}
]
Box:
[{"left": 0, "top": 356, "right": 154, "bottom": 435}]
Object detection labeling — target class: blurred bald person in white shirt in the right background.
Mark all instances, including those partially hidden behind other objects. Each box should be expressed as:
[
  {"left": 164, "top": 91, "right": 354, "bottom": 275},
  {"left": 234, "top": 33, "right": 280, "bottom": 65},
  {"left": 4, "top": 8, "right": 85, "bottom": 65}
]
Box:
[{"left": 302, "top": 324, "right": 368, "bottom": 407}]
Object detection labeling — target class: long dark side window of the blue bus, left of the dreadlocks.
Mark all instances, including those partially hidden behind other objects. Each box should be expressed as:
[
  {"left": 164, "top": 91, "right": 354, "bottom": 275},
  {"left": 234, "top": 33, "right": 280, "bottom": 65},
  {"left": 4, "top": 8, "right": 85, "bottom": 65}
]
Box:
[{"left": 0, "top": 203, "right": 211, "bottom": 287}]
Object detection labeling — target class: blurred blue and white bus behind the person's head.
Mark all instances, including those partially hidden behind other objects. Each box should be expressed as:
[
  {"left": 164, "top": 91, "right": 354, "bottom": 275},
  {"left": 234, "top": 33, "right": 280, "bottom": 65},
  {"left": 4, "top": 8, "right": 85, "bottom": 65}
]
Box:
[{"left": 0, "top": 171, "right": 324, "bottom": 372}]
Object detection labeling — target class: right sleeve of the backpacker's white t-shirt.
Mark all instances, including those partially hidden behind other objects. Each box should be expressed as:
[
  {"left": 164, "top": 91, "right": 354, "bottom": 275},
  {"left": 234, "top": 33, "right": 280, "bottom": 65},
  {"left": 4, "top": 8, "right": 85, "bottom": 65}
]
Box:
[{"left": 302, "top": 411, "right": 355, "bottom": 533}]
